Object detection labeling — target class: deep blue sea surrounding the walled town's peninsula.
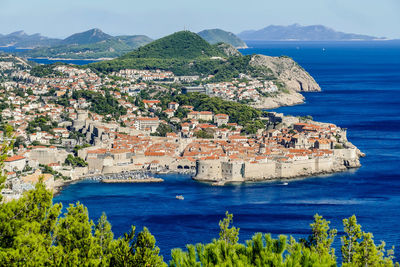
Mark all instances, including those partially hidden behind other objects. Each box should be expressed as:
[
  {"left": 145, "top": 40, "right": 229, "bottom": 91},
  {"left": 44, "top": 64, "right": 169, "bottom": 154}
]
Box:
[{"left": 54, "top": 42, "right": 400, "bottom": 259}]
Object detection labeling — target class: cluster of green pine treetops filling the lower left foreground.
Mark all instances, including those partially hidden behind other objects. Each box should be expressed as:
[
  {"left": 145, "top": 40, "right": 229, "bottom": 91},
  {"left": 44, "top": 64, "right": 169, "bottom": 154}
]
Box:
[{"left": 0, "top": 183, "right": 166, "bottom": 266}]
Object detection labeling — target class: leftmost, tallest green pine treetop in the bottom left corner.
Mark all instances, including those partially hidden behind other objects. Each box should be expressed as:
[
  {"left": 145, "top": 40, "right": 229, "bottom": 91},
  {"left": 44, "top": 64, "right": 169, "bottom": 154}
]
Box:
[{"left": 0, "top": 183, "right": 62, "bottom": 266}]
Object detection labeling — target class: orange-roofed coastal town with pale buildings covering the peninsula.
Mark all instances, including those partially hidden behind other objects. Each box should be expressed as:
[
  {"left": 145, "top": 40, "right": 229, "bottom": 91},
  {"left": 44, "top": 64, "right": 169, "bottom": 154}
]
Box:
[{"left": 0, "top": 55, "right": 362, "bottom": 199}]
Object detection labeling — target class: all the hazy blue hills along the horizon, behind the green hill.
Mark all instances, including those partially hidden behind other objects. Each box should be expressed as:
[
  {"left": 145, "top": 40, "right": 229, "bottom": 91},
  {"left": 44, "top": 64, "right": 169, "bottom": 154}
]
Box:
[{"left": 0, "top": 24, "right": 386, "bottom": 59}]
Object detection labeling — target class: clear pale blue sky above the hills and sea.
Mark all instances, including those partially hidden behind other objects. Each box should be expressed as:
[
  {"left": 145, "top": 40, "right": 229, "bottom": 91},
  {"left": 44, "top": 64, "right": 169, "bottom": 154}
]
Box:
[{"left": 0, "top": 0, "right": 400, "bottom": 39}]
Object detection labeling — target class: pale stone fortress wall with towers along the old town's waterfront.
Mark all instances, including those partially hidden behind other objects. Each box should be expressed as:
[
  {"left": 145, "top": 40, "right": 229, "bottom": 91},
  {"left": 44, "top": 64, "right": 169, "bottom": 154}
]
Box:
[{"left": 194, "top": 148, "right": 360, "bottom": 183}]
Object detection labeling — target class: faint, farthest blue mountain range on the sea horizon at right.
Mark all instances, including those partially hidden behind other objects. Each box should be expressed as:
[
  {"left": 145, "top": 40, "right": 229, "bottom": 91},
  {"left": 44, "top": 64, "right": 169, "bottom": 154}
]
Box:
[{"left": 238, "top": 24, "right": 386, "bottom": 41}]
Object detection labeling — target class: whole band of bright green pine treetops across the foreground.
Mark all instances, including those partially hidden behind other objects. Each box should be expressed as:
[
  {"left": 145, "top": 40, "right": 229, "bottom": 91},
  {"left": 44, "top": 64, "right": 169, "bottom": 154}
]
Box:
[{"left": 0, "top": 137, "right": 399, "bottom": 267}]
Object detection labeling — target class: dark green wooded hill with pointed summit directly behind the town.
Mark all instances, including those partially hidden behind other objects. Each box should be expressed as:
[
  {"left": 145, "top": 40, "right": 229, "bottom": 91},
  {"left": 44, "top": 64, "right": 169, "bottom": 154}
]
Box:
[{"left": 87, "top": 31, "right": 274, "bottom": 81}]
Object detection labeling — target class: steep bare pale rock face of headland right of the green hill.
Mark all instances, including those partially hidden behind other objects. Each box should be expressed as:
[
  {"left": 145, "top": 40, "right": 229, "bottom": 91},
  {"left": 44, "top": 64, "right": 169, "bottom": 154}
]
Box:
[{"left": 250, "top": 55, "right": 321, "bottom": 92}]
